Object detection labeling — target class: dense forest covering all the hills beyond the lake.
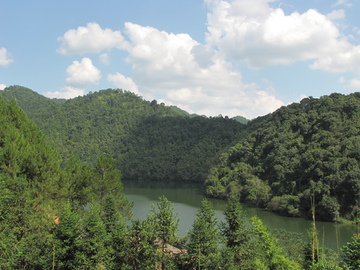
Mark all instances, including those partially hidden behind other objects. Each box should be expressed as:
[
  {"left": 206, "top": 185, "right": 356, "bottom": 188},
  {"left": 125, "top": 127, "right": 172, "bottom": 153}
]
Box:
[{"left": 0, "top": 86, "right": 360, "bottom": 222}]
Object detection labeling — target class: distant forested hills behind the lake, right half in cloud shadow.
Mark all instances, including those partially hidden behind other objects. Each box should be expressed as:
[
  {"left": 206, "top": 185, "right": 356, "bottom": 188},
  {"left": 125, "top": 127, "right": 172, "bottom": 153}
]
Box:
[{"left": 0, "top": 86, "right": 245, "bottom": 184}]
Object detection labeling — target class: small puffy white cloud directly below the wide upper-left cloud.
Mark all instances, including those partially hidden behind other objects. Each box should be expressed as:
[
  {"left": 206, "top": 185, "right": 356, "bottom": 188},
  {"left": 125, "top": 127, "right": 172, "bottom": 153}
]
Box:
[{"left": 66, "top": 57, "right": 101, "bottom": 86}]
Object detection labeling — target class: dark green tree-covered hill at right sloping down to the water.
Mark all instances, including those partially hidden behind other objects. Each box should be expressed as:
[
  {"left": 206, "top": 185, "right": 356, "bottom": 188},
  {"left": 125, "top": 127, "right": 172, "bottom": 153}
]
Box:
[{"left": 206, "top": 93, "right": 360, "bottom": 220}]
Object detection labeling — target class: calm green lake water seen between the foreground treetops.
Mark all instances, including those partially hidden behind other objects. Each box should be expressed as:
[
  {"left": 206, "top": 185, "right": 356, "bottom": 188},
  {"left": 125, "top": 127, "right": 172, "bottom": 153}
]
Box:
[{"left": 124, "top": 182, "right": 358, "bottom": 251}]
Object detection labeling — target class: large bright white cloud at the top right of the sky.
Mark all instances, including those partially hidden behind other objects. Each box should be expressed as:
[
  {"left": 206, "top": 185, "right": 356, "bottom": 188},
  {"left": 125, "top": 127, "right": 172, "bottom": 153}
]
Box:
[{"left": 207, "top": 0, "right": 354, "bottom": 70}]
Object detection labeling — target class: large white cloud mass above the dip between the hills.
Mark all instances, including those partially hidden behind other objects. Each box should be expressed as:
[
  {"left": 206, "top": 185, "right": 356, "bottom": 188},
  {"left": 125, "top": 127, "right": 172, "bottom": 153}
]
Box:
[{"left": 119, "top": 23, "right": 283, "bottom": 118}]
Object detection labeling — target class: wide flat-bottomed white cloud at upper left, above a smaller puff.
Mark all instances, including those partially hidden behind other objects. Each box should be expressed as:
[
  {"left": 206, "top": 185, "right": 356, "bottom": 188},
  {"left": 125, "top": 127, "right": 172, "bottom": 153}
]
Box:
[{"left": 58, "top": 22, "right": 127, "bottom": 54}]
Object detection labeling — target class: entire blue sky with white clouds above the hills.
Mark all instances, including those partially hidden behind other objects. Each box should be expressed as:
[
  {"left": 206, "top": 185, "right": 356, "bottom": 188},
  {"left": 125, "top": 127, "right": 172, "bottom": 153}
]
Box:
[{"left": 0, "top": 0, "right": 360, "bottom": 119}]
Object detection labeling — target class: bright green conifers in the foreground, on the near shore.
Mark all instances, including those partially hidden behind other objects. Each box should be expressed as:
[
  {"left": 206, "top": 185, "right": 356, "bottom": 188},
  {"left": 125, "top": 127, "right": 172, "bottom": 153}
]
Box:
[{"left": 0, "top": 90, "right": 360, "bottom": 270}]
